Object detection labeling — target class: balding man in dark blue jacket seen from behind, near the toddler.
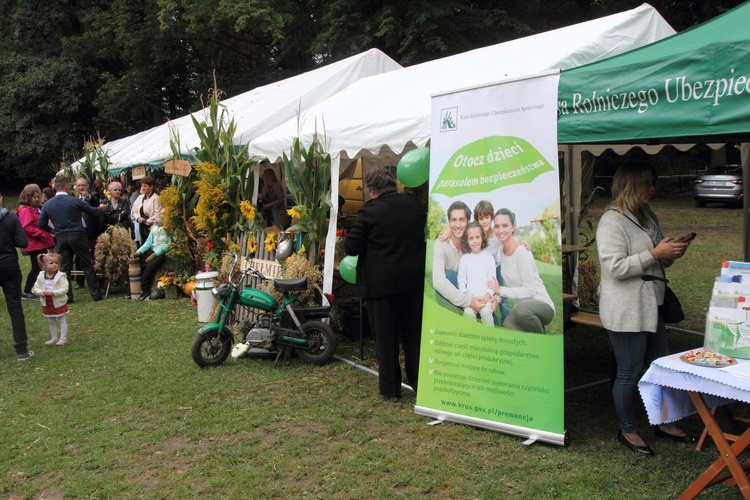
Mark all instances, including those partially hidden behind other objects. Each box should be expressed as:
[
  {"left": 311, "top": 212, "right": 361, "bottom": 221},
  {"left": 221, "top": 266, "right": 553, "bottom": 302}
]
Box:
[{"left": 39, "top": 175, "right": 102, "bottom": 303}]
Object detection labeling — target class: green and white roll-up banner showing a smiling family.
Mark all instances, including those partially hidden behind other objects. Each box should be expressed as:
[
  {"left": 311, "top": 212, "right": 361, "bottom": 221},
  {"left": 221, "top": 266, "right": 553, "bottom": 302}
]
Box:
[{"left": 415, "top": 73, "right": 564, "bottom": 445}]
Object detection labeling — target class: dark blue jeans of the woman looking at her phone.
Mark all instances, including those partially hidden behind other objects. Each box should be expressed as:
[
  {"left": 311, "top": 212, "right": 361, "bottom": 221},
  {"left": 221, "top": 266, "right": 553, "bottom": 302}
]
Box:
[{"left": 607, "top": 316, "right": 669, "bottom": 432}]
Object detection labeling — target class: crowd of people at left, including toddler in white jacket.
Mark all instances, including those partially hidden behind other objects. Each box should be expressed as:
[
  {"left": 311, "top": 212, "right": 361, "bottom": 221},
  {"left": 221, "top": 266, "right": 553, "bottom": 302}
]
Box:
[{"left": 0, "top": 175, "right": 171, "bottom": 361}]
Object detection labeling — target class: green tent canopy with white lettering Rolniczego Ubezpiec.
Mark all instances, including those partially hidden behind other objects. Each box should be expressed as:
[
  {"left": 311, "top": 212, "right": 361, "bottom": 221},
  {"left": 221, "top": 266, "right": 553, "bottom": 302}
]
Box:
[{"left": 558, "top": 2, "right": 750, "bottom": 144}]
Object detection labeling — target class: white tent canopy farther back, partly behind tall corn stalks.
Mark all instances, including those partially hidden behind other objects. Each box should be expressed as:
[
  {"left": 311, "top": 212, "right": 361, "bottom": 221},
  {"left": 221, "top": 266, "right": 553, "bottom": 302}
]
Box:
[{"left": 103, "top": 49, "right": 401, "bottom": 173}]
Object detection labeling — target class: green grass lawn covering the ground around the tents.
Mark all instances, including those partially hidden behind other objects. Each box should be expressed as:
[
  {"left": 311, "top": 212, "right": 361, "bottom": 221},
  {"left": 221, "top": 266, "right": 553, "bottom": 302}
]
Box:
[{"left": 0, "top": 191, "right": 743, "bottom": 499}]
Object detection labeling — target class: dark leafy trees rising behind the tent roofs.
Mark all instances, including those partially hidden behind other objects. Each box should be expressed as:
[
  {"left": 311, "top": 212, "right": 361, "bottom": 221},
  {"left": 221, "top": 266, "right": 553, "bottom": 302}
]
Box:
[{"left": 0, "top": 0, "right": 742, "bottom": 189}]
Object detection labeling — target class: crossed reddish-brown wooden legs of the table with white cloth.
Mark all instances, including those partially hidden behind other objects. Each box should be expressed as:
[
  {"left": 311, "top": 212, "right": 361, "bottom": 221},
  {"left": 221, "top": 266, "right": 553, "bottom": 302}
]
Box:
[{"left": 679, "top": 392, "right": 750, "bottom": 499}]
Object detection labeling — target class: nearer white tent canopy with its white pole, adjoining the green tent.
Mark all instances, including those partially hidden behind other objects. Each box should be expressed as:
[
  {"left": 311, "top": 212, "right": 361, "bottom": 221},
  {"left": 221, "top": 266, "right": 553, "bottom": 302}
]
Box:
[{"left": 249, "top": 4, "right": 675, "bottom": 290}]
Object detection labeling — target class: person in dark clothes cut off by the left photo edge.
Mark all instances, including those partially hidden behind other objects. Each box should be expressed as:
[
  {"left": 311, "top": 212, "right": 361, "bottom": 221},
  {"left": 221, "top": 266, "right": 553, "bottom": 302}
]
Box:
[{"left": 0, "top": 191, "right": 34, "bottom": 361}]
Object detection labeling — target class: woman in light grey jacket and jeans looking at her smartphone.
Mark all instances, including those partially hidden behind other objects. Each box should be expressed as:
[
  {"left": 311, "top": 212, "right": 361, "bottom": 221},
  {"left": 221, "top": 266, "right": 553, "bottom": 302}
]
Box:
[{"left": 596, "top": 161, "right": 695, "bottom": 456}]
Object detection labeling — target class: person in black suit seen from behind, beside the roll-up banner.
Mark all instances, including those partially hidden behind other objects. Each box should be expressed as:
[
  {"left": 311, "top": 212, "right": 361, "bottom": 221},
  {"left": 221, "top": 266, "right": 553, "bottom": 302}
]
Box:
[{"left": 344, "top": 167, "right": 427, "bottom": 398}]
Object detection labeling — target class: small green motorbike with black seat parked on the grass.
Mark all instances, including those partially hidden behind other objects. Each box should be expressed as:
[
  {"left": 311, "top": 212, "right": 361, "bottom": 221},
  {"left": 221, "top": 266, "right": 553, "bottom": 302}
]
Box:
[{"left": 191, "top": 253, "right": 337, "bottom": 367}]
